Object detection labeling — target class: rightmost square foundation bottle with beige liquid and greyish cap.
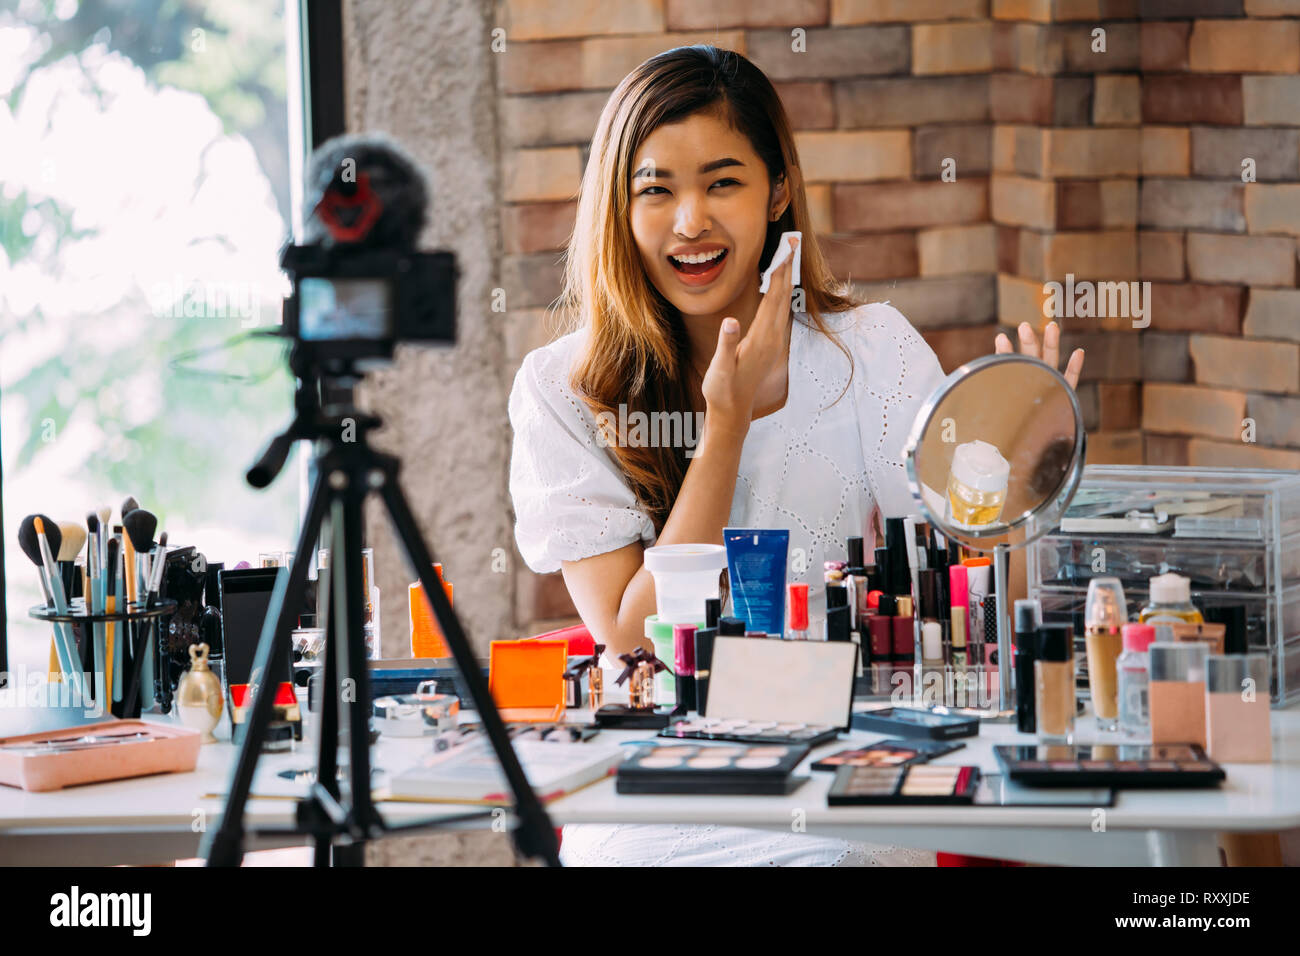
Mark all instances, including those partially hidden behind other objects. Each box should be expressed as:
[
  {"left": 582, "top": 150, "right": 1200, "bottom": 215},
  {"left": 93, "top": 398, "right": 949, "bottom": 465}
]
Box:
[{"left": 1205, "top": 654, "right": 1273, "bottom": 763}]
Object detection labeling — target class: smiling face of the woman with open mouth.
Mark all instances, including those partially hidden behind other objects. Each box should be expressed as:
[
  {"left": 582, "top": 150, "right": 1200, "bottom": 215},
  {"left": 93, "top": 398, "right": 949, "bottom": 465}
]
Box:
[{"left": 632, "top": 112, "right": 787, "bottom": 315}]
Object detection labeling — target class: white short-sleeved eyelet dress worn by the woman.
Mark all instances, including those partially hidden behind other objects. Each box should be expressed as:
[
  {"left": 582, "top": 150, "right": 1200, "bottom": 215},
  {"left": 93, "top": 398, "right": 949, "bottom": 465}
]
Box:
[{"left": 510, "top": 303, "right": 944, "bottom": 866}]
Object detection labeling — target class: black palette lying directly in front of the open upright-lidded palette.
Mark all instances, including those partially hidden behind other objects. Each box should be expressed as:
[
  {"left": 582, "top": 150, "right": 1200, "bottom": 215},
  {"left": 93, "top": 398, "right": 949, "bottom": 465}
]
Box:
[{"left": 615, "top": 744, "right": 809, "bottom": 795}]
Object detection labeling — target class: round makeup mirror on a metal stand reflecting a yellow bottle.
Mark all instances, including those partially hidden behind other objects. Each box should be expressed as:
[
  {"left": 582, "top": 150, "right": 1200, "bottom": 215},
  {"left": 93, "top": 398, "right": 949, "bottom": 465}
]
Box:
[{"left": 906, "top": 354, "right": 1086, "bottom": 717}]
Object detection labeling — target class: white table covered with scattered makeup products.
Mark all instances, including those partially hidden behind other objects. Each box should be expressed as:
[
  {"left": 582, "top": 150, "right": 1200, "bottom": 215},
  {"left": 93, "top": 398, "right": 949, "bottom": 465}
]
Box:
[{"left": 0, "top": 708, "right": 1300, "bottom": 866}]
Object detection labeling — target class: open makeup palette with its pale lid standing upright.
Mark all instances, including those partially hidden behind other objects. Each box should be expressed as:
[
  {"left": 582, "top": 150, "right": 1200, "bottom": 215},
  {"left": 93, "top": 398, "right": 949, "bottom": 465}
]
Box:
[{"left": 659, "top": 637, "right": 858, "bottom": 747}]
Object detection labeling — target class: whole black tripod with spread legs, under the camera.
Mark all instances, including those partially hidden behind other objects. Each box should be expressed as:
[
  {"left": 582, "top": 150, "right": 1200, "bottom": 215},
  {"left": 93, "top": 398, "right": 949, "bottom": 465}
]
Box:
[{"left": 203, "top": 346, "right": 559, "bottom": 866}]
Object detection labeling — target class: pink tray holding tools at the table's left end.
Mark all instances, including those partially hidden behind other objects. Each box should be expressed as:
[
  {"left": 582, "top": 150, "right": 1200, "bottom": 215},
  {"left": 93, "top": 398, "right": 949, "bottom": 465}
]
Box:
[{"left": 0, "top": 721, "right": 203, "bottom": 791}]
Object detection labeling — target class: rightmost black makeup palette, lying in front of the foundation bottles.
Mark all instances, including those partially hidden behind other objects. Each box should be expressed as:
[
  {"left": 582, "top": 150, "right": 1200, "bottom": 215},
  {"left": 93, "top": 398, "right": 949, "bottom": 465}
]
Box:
[{"left": 993, "top": 744, "right": 1227, "bottom": 790}]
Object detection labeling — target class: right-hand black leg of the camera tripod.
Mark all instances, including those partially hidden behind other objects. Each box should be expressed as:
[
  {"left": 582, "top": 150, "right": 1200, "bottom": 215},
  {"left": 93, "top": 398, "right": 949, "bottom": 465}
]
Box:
[{"left": 380, "top": 470, "right": 560, "bottom": 866}]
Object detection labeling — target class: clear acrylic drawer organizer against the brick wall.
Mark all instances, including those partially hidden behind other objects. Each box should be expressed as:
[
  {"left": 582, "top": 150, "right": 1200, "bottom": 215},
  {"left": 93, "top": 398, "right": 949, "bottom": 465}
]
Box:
[{"left": 1027, "top": 464, "right": 1300, "bottom": 706}]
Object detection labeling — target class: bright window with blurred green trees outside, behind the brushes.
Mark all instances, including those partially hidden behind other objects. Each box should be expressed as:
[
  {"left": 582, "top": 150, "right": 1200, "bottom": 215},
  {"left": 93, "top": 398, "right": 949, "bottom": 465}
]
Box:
[{"left": 0, "top": 0, "right": 299, "bottom": 671}]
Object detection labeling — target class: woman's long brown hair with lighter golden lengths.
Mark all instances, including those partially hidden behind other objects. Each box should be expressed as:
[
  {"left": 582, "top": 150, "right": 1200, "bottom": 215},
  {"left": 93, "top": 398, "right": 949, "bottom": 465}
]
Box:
[{"left": 560, "top": 44, "right": 858, "bottom": 533}]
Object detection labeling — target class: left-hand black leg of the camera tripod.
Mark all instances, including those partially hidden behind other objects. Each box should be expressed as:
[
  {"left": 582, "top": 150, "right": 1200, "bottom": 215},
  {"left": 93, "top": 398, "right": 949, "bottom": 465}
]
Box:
[{"left": 203, "top": 476, "right": 328, "bottom": 866}]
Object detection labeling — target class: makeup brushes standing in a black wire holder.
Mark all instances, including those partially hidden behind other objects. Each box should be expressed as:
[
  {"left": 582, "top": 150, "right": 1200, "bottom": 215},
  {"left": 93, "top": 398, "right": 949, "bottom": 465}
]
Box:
[{"left": 18, "top": 497, "right": 183, "bottom": 717}]
